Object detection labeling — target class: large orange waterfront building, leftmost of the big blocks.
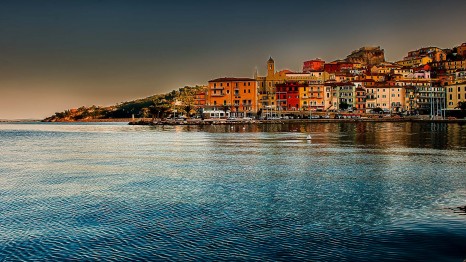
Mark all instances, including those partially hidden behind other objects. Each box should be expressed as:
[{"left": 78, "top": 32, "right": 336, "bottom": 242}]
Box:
[{"left": 207, "top": 77, "right": 257, "bottom": 117}]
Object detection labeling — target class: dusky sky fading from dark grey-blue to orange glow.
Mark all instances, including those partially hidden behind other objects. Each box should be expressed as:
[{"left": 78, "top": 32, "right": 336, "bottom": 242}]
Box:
[{"left": 0, "top": 0, "right": 466, "bottom": 119}]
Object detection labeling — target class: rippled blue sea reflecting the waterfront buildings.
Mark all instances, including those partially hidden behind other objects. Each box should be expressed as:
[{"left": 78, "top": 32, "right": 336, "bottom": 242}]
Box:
[{"left": 0, "top": 123, "right": 466, "bottom": 261}]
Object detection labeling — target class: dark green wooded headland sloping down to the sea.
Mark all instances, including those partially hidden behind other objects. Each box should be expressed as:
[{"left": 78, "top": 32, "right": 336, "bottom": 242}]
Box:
[{"left": 43, "top": 86, "right": 204, "bottom": 122}]
